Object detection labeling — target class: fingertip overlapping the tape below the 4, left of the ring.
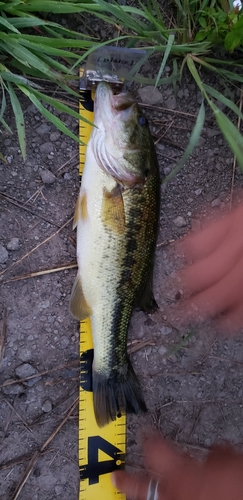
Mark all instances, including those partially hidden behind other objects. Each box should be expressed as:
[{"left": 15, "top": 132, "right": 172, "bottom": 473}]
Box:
[{"left": 111, "top": 471, "right": 153, "bottom": 500}]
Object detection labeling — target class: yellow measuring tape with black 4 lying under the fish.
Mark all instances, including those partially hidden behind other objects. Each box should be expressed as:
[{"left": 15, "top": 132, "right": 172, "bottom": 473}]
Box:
[{"left": 78, "top": 80, "right": 126, "bottom": 500}]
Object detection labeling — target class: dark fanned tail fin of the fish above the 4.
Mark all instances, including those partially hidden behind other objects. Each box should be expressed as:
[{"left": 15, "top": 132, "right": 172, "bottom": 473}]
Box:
[{"left": 93, "top": 361, "right": 147, "bottom": 427}]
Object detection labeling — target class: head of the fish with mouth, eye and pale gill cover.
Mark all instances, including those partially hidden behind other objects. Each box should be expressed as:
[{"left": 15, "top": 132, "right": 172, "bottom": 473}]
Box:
[{"left": 92, "top": 82, "right": 154, "bottom": 187}]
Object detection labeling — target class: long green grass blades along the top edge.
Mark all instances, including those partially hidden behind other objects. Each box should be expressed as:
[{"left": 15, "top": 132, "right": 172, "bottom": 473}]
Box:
[{"left": 0, "top": 0, "right": 243, "bottom": 172}]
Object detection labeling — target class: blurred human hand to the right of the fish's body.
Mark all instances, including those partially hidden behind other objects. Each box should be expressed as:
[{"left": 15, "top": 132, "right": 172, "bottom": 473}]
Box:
[{"left": 178, "top": 203, "right": 243, "bottom": 330}]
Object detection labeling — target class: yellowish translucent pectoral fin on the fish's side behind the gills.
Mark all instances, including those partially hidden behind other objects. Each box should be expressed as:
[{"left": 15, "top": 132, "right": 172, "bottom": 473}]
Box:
[{"left": 101, "top": 185, "right": 125, "bottom": 234}]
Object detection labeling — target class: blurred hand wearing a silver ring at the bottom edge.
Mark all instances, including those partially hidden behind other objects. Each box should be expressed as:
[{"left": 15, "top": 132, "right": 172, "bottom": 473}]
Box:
[{"left": 112, "top": 436, "right": 243, "bottom": 500}]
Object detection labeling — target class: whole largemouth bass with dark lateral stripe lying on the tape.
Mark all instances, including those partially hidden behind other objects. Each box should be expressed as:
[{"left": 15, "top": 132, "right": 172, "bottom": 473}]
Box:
[{"left": 71, "top": 82, "right": 160, "bottom": 427}]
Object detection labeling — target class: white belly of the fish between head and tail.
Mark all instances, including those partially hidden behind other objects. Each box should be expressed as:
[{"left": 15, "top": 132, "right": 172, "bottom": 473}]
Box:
[{"left": 77, "top": 146, "right": 125, "bottom": 371}]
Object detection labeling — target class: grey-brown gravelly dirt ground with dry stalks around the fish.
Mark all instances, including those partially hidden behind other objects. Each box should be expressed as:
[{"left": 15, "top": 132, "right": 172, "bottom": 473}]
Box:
[{"left": 0, "top": 17, "right": 243, "bottom": 500}]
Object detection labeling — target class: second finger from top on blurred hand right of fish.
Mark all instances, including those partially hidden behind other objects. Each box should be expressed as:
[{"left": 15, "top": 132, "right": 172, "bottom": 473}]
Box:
[{"left": 178, "top": 232, "right": 243, "bottom": 294}]
